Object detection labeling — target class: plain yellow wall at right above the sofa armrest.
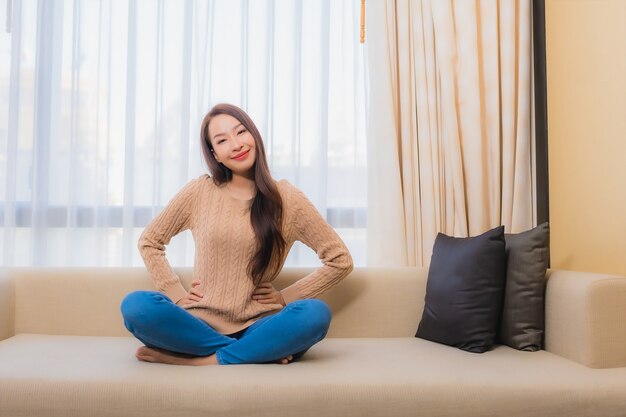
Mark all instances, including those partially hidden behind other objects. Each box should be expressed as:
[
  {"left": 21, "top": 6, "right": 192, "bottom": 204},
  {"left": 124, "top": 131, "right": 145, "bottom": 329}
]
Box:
[{"left": 546, "top": 0, "right": 626, "bottom": 276}]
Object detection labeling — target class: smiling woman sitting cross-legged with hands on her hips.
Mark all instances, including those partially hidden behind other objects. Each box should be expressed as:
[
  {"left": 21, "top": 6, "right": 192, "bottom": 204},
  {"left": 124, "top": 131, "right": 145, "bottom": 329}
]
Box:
[{"left": 121, "top": 104, "right": 352, "bottom": 365}]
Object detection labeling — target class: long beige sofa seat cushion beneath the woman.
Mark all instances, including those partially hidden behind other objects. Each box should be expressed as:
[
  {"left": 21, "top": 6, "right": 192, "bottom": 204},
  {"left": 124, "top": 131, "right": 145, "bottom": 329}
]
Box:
[{"left": 0, "top": 334, "right": 626, "bottom": 417}]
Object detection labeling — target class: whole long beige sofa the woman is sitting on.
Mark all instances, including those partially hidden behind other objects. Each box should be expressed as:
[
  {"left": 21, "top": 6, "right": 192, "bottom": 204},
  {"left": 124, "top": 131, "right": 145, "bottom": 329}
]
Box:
[{"left": 0, "top": 268, "right": 626, "bottom": 417}]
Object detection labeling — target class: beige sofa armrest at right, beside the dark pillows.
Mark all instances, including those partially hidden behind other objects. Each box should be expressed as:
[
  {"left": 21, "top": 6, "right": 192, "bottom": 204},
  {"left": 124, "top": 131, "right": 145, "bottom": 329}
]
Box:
[{"left": 545, "top": 270, "right": 626, "bottom": 368}]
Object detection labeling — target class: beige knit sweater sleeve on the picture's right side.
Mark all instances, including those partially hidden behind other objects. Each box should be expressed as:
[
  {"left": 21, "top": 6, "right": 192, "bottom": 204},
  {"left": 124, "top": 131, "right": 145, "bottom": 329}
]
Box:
[{"left": 281, "top": 184, "right": 353, "bottom": 303}]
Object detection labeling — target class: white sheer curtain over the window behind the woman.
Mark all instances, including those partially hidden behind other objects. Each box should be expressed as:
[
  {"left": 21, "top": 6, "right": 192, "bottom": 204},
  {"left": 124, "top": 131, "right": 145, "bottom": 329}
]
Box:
[{"left": 0, "top": 0, "right": 367, "bottom": 266}]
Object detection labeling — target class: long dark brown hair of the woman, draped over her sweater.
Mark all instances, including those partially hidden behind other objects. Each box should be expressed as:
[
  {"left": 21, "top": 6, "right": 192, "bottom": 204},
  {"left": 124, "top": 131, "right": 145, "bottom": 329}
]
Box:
[{"left": 200, "top": 103, "right": 285, "bottom": 284}]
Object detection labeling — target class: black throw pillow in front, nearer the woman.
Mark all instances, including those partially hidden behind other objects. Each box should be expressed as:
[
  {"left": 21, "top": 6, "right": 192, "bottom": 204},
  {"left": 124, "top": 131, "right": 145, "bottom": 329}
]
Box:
[{"left": 415, "top": 226, "right": 506, "bottom": 353}]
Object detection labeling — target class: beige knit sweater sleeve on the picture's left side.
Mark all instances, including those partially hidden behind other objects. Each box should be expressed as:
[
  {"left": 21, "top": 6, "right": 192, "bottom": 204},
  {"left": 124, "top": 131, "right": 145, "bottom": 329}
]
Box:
[{"left": 138, "top": 178, "right": 200, "bottom": 303}]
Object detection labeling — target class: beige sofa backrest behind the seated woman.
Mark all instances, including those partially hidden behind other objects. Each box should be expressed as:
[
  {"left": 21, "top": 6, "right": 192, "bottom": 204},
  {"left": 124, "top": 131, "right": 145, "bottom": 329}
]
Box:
[{"left": 11, "top": 267, "right": 428, "bottom": 337}]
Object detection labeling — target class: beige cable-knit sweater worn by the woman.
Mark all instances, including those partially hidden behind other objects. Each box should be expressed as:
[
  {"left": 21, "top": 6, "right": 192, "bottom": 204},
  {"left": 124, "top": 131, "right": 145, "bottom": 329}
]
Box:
[{"left": 139, "top": 175, "right": 352, "bottom": 334}]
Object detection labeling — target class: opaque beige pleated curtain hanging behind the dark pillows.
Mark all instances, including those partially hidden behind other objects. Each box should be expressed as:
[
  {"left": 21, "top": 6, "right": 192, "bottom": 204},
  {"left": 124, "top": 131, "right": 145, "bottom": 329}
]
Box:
[{"left": 366, "top": 0, "right": 536, "bottom": 266}]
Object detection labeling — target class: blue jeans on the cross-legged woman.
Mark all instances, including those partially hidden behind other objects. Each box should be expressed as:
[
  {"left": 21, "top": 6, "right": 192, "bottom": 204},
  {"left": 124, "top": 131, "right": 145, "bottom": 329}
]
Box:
[{"left": 121, "top": 291, "right": 331, "bottom": 365}]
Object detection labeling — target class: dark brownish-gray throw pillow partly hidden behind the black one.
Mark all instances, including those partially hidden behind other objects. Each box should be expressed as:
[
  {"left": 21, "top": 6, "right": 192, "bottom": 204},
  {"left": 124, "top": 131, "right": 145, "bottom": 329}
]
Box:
[{"left": 497, "top": 223, "right": 550, "bottom": 352}]
